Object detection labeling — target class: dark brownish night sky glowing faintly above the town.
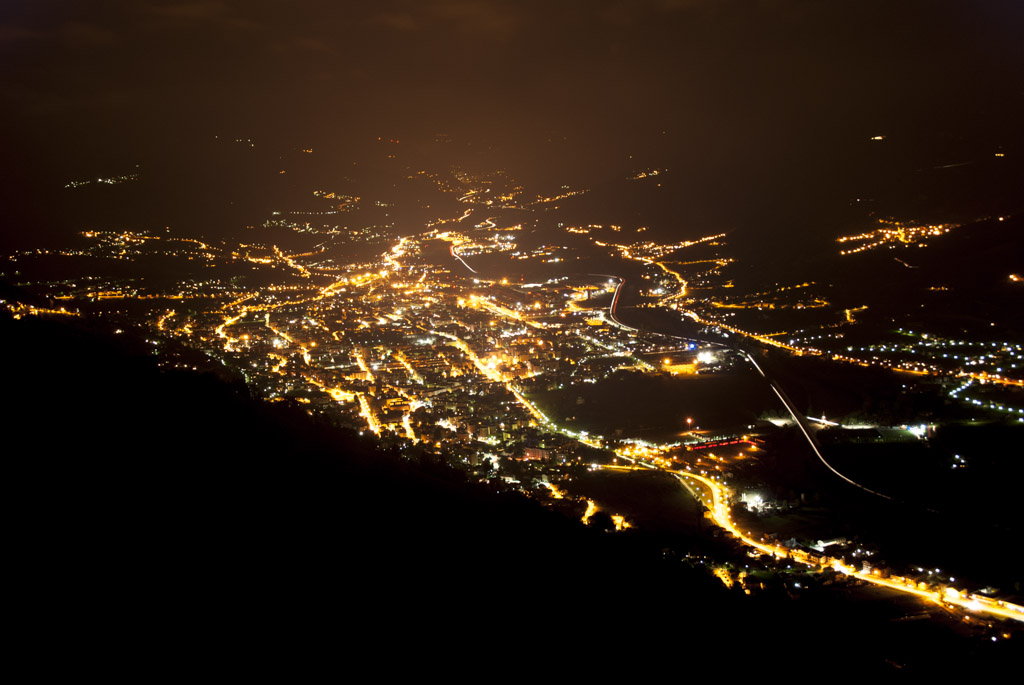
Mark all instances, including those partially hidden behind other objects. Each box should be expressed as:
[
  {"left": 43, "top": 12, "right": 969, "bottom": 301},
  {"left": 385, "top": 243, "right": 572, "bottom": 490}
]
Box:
[{"left": 0, "top": 0, "right": 1024, "bottom": 248}]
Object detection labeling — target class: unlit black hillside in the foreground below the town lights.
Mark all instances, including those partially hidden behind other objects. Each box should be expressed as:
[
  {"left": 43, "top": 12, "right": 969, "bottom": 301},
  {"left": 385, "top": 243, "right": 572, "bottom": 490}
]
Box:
[{"left": 6, "top": 316, "right": 1015, "bottom": 675}]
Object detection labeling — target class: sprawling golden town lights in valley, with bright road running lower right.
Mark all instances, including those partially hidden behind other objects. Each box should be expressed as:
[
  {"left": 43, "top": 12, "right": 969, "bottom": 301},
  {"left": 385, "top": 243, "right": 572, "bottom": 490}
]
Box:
[{"left": 5, "top": 176, "right": 1024, "bottom": 620}]
